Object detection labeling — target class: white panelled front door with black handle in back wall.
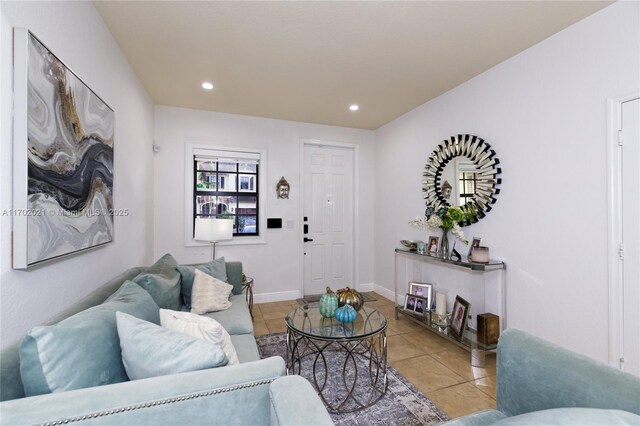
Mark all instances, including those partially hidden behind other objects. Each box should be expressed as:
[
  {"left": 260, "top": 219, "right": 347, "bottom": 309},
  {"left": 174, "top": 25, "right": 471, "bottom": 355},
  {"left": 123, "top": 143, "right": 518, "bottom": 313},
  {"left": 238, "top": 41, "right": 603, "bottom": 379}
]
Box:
[{"left": 304, "top": 144, "right": 355, "bottom": 295}]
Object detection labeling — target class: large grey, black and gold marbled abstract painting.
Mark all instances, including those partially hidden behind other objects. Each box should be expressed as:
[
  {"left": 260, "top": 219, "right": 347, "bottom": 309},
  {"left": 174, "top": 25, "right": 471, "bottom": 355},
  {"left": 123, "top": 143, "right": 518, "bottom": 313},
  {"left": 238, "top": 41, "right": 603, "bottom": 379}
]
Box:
[{"left": 12, "top": 28, "right": 114, "bottom": 269}]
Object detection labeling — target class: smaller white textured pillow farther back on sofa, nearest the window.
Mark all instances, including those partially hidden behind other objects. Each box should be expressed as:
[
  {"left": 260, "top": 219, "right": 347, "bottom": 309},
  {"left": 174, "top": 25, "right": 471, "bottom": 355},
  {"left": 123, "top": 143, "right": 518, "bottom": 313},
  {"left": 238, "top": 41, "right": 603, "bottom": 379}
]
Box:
[{"left": 191, "top": 269, "right": 233, "bottom": 314}]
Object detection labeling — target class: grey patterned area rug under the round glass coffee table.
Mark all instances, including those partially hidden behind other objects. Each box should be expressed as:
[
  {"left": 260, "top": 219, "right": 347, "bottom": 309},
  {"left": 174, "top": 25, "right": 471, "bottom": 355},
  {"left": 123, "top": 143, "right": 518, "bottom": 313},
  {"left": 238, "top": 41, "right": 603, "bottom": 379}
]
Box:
[{"left": 256, "top": 333, "right": 448, "bottom": 426}]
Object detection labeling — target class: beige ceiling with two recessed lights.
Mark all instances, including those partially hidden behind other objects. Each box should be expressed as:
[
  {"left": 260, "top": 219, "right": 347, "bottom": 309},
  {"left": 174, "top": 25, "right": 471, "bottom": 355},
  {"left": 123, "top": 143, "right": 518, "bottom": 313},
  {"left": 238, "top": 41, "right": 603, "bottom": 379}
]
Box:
[{"left": 94, "top": 1, "right": 611, "bottom": 129}]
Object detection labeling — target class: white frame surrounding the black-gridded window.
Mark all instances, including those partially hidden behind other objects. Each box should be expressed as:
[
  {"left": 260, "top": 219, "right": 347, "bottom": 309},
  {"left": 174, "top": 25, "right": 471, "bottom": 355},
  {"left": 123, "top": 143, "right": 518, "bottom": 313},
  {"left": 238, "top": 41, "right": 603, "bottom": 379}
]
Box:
[{"left": 184, "top": 140, "right": 268, "bottom": 247}]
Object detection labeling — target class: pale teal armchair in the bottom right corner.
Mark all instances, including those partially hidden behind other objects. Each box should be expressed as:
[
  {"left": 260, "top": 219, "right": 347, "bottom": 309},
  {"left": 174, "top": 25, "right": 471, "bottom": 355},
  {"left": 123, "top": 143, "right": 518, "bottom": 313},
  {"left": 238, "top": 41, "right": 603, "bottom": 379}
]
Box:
[{"left": 444, "top": 329, "right": 640, "bottom": 426}]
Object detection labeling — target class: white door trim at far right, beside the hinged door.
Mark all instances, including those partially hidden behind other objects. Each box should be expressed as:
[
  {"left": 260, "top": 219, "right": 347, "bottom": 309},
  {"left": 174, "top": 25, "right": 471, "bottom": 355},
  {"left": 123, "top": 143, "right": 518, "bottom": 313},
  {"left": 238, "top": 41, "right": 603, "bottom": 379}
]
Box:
[{"left": 607, "top": 91, "right": 640, "bottom": 369}]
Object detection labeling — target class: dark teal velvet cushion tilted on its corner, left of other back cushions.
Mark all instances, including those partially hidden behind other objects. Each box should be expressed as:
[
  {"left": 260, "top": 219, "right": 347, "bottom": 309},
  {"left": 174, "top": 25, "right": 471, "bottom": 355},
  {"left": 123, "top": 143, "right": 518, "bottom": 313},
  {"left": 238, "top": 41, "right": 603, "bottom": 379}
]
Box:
[{"left": 132, "top": 253, "right": 182, "bottom": 310}]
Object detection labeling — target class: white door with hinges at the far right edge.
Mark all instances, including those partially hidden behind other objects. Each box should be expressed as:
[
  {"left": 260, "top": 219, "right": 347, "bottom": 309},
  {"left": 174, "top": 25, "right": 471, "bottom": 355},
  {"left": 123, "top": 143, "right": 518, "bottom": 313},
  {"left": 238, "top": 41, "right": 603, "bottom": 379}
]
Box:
[{"left": 622, "top": 99, "right": 640, "bottom": 376}]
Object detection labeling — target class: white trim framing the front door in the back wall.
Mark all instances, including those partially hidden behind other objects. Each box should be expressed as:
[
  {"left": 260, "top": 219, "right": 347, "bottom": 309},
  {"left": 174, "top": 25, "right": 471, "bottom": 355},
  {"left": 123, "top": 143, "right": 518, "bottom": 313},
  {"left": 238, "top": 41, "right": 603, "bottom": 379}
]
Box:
[{"left": 298, "top": 138, "right": 360, "bottom": 297}]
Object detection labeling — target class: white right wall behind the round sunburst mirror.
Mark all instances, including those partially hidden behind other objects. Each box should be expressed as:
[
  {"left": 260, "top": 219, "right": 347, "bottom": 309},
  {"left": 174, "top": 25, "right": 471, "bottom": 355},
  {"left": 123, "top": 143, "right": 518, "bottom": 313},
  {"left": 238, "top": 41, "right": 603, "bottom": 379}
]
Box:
[{"left": 375, "top": 2, "right": 640, "bottom": 362}]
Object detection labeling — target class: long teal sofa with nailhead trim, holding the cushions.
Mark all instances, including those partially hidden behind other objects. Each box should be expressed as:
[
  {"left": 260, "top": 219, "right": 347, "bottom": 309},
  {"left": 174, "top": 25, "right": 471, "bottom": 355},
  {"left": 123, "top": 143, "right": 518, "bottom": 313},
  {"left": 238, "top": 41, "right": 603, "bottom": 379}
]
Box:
[{"left": 0, "top": 262, "right": 333, "bottom": 425}]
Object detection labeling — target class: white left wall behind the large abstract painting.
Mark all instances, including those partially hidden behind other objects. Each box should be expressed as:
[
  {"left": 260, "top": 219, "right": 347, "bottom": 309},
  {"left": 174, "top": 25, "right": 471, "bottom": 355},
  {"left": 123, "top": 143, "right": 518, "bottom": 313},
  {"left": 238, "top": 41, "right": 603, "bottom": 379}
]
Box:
[{"left": 0, "top": 1, "right": 153, "bottom": 348}]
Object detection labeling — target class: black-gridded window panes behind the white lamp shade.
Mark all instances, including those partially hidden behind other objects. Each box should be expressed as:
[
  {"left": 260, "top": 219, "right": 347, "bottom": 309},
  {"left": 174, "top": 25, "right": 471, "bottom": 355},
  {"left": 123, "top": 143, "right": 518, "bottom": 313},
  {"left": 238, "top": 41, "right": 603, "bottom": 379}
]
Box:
[{"left": 192, "top": 148, "right": 260, "bottom": 237}]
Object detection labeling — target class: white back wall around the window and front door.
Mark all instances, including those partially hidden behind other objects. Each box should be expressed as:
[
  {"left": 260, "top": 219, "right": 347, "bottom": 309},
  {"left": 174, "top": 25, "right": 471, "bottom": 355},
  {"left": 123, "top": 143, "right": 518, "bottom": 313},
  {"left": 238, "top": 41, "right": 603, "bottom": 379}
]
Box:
[{"left": 154, "top": 106, "right": 374, "bottom": 301}]
